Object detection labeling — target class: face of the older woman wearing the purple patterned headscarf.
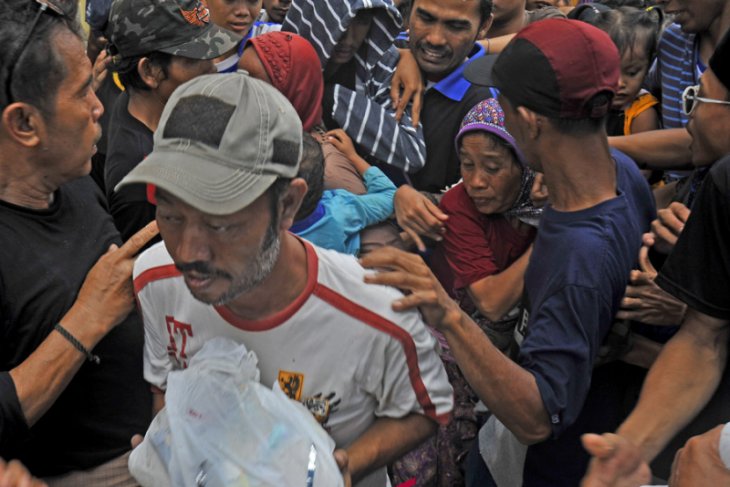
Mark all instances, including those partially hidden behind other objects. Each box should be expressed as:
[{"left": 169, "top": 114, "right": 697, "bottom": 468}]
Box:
[{"left": 459, "top": 132, "right": 522, "bottom": 215}]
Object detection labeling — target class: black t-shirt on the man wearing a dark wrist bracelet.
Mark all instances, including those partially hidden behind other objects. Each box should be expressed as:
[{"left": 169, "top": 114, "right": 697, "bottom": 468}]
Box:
[{"left": 0, "top": 177, "right": 152, "bottom": 476}]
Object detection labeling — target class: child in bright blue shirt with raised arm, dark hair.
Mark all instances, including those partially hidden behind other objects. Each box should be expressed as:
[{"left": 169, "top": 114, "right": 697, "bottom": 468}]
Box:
[{"left": 290, "top": 129, "right": 396, "bottom": 255}]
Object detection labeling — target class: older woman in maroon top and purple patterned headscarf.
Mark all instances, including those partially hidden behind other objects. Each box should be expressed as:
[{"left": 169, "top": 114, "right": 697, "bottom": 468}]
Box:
[{"left": 393, "top": 98, "right": 541, "bottom": 486}]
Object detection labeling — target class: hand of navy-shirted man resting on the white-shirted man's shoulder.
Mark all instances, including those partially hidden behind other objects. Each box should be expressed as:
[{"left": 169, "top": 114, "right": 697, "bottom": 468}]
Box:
[{"left": 360, "top": 247, "right": 461, "bottom": 329}]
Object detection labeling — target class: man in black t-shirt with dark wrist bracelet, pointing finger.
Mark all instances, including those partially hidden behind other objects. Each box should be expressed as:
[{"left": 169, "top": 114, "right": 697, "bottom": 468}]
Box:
[{"left": 0, "top": 0, "right": 155, "bottom": 486}]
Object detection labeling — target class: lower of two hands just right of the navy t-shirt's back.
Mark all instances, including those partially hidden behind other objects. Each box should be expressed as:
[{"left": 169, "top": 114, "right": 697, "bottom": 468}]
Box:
[{"left": 616, "top": 270, "right": 687, "bottom": 326}]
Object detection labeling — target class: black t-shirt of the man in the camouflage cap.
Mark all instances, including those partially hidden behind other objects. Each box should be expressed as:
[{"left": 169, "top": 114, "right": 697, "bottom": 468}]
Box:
[{"left": 104, "top": 93, "right": 157, "bottom": 243}]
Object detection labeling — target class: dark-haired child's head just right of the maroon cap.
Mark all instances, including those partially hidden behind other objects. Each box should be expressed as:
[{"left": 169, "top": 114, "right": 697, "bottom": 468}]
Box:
[{"left": 592, "top": 7, "right": 659, "bottom": 109}]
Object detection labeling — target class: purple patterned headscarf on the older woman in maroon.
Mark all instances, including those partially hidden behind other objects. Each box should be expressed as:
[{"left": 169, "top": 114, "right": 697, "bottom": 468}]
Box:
[{"left": 455, "top": 98, "right": 542, "bottom": 226}]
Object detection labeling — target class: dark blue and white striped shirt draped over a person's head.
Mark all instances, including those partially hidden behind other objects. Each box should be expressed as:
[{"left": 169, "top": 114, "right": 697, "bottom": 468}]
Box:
[{"left": 282, "top": 0, "right": 426, "bottom": 173}]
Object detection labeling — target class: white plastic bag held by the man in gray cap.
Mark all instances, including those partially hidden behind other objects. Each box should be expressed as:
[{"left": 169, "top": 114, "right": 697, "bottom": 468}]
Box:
[{"left": 129, "top": 338, "right": 343, "bottom": 487}]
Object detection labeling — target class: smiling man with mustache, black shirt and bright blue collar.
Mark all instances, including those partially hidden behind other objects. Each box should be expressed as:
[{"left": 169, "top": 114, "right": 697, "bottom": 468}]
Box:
[{"left": 395, "top": 0, "right": 493, "bottom": 250}]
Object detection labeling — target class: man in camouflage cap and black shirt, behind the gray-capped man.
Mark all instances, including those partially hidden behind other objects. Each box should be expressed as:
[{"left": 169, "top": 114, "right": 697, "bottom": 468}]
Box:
[{"left": 104, "top": 0, "right": 241, "bottom": 244}]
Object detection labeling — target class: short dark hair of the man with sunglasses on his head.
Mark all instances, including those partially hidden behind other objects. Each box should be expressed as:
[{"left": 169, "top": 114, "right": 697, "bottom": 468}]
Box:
[{"left": 0, "top": 0, "right": 81, "bottom": 115}]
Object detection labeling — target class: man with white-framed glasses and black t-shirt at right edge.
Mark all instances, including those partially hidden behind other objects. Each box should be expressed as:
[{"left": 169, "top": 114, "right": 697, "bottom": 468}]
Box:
[{"left": 583, "top": 27, "right": 730, "bottom": 487}]
